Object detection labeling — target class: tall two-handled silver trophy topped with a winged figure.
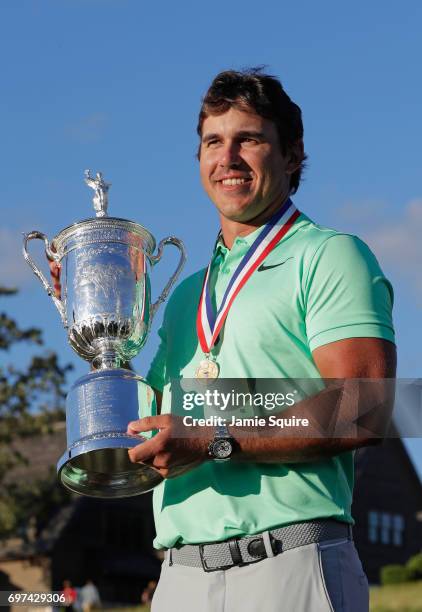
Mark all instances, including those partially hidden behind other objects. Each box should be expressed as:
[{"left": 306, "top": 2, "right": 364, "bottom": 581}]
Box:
[{"left": 23, "top": 170, "right": 186, "bottom": 498}]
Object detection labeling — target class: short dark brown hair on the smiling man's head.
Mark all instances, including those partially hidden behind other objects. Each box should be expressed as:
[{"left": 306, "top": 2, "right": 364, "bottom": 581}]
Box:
[{"left": 197, "top": 67, "right": 307, "bottom": 193}]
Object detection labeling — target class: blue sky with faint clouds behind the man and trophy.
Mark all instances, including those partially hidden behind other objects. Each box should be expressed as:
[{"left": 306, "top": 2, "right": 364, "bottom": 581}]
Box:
[{"left": 0, "top": 0, "right": 422, "bottom": 470}]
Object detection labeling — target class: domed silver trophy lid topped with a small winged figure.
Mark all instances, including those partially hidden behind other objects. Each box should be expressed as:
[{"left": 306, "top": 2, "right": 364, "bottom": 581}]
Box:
[{"left": 52, "top": 170, "right": 156, "bottom": 257}]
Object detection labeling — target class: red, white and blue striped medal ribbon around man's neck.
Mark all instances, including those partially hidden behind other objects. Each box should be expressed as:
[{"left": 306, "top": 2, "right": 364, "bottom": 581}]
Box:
[{"left": 196, "top": 198, "right": 300, "bottom": 355}]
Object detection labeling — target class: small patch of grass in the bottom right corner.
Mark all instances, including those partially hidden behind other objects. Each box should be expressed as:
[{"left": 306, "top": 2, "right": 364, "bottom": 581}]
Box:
[{"left": 370, "top": 580, "right": 422, "bottom": 612}]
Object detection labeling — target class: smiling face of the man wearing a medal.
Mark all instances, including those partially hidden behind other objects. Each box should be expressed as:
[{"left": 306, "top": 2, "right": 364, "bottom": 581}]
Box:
[{"left": 200, "top": 107, "right": 295, "bottom": 223}]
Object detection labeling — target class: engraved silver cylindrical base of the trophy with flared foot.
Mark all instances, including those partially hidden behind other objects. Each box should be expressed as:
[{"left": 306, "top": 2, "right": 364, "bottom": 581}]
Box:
[{"left": 57, "top": 369, "right": 163, "bottom": 499}]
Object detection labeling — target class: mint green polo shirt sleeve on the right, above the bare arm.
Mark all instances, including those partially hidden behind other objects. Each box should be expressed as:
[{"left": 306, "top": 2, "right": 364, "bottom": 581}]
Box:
[{"left": 304, "top": 234, "right": 395, "bottom": 351}]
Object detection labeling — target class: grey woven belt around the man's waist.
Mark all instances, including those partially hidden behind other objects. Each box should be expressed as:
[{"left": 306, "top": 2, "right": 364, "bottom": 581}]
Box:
[{"left": 166, "top": 519, "right": 353, "bottom": 572}]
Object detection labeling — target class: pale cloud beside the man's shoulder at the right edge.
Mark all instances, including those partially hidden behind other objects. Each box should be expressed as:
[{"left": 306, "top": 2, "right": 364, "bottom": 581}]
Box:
[{"left": 340, "top": 198, "right": 422, "bottom": 300}]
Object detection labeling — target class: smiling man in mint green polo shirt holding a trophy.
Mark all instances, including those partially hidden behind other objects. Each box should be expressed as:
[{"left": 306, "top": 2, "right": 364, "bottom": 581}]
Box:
[{"left": 128, "top": 70, "right": 395, "bottom": 612}]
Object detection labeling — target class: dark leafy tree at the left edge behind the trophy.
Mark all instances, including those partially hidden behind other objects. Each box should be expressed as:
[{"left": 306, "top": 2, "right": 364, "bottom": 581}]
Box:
[{"left": 0, "top": 287, "right": 72, "bottom": 537}]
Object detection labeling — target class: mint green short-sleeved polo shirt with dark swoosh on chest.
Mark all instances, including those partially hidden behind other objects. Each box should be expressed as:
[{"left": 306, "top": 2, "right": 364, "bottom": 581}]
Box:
[{"left": 147, "top": 214, "right": 394, "bottom": 548}]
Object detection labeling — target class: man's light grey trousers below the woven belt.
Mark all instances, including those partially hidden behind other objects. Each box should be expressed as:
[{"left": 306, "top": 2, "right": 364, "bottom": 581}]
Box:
[{"left": 151, "top": 539, "right": 369, "bottom": 612}]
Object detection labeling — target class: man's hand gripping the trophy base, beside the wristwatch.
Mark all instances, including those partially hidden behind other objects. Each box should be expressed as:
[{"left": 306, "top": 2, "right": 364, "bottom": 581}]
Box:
[{"left": 127, "top": 414, "right": 213, "bottom": 478}]
